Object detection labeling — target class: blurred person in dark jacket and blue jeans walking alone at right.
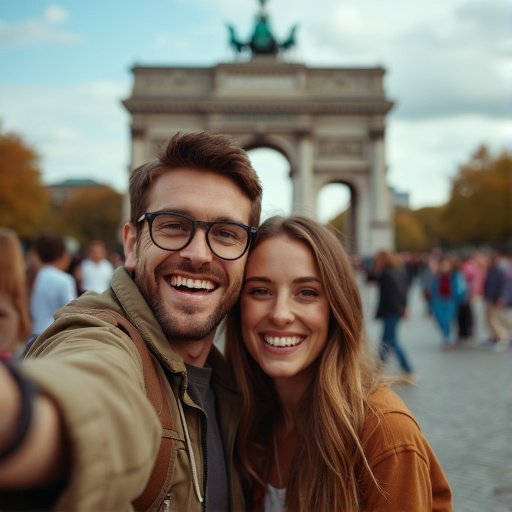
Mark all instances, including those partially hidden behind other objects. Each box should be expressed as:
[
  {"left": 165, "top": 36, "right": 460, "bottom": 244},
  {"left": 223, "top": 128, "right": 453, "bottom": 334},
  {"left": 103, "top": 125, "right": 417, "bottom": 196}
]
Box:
[{"left": 368, "top": 250, "right": 413, "bottom": 380}]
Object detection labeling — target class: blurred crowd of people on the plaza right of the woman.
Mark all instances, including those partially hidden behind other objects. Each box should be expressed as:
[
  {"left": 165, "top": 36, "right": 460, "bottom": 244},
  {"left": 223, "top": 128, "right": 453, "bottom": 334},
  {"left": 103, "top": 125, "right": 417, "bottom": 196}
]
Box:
[{"left": 362, "top": 248, "right": 512, "bottom": 382}]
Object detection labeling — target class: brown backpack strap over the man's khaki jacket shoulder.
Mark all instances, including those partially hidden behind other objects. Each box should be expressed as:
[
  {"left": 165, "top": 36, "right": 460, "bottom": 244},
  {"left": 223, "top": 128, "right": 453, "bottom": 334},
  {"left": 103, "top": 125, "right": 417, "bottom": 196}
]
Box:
[{"left": 61, "top": 307, "right": 173, "bottom": 511}]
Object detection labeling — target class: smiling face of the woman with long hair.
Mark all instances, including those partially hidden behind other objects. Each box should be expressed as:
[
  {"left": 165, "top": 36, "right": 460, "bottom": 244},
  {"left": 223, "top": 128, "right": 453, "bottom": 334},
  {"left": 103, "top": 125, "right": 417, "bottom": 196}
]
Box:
[{"left": 240, "top": 235, "right": 330, "bottom": 379}]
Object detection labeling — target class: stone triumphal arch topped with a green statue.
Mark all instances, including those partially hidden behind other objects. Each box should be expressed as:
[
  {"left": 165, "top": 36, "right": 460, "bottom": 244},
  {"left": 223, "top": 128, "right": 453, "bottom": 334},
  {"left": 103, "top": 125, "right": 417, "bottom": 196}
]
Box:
[{"left": 123, "top": 0, "right": 393, "bottom": 256}]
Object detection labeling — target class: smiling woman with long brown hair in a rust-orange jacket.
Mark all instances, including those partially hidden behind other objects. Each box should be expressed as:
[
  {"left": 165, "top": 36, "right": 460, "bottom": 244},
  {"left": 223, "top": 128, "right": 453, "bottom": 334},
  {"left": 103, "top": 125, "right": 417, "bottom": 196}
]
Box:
[{"left": 226, "top": 216, "right": 451, "bottom": 512}]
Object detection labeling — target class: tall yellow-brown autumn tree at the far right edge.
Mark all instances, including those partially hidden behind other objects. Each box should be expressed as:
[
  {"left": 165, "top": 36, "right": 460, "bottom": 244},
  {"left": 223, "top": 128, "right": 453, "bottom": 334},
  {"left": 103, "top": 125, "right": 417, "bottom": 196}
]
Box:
[{"left": 440, "top": 146, "right": 512, "bottom": 247}]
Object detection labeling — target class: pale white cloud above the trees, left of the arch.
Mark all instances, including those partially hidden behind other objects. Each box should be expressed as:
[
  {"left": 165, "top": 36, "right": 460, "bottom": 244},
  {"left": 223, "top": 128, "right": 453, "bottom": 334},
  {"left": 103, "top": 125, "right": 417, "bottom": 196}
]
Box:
[{"left": 0, "top": 82, "right": 130, "bottom": 192}]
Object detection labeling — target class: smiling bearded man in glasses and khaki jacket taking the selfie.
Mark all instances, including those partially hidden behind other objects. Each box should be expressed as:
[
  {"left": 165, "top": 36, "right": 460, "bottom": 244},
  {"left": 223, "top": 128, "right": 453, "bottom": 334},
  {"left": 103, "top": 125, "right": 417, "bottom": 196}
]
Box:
[{"left": 0, "top": 133, "right": 261, "bottom": 511}]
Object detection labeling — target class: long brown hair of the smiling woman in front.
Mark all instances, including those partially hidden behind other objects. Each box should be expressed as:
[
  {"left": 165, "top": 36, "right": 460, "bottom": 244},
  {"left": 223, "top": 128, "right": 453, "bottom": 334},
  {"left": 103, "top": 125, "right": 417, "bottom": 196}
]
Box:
[{"left": 226, "top": 216, "right": 379, "bottom": 512}]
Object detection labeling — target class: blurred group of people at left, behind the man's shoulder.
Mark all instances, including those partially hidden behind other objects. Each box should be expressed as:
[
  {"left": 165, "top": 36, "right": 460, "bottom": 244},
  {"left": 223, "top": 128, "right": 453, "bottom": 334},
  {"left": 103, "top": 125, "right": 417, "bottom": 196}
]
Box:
[{"left": 0, "top": 227, "right": 123, "bottom": 359}]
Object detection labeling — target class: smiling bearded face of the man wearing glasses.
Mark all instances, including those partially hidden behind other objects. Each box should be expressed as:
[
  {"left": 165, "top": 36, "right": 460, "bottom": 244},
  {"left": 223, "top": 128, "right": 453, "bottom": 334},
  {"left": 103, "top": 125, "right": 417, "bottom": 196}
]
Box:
[{"left": 125, "top": 168, "right": 251, "bottom": 342}]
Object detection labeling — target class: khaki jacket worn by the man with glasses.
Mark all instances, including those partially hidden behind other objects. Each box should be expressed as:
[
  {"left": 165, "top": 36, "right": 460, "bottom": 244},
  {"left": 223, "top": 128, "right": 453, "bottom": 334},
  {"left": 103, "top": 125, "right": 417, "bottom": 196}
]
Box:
[{"left": 22, "top": 268, "right": 244, "bottom": 512}]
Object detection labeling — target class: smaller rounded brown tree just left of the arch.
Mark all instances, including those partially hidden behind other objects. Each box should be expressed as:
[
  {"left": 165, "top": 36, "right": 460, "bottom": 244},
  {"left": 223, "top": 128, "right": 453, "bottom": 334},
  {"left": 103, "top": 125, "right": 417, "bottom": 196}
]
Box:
[{"left": 54, "top": 185, "right": 123, "bottom": 250}]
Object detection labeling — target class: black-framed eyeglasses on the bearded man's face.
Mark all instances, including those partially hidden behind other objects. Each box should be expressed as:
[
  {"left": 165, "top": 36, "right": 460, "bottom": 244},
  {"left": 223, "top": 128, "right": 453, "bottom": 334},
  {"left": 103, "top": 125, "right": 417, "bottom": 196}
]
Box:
[{"left": 137, "top": 212, "right": 258, "bottom": 260}]
